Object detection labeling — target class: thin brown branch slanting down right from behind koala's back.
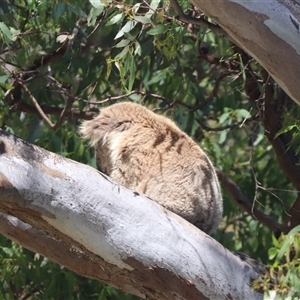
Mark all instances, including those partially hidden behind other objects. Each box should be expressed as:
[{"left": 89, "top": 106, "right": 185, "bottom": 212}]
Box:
[{"left": 216, "top": 169, "right": 281, "bottom": 236}]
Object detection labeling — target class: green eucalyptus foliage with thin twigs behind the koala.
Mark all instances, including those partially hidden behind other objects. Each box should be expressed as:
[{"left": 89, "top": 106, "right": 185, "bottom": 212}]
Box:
[{"left": 0, "top": 0, "right": 300, "bottom": 299}]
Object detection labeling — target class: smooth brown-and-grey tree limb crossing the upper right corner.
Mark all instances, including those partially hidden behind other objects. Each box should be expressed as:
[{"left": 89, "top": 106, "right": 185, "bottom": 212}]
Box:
[{"left": 191, "top": 0, "right": 300, "bottom": 104}]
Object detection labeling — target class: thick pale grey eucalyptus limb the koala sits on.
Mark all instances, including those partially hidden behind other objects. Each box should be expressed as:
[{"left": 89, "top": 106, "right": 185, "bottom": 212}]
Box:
[{"left": 0, "top": 130, "right": 262, "bottom": 300}]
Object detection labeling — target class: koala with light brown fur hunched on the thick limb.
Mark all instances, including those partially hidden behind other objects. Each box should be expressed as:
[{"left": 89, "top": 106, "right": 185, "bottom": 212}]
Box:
[{"left": 80, "top": 102, "right": 223, "bottom": 234}]
